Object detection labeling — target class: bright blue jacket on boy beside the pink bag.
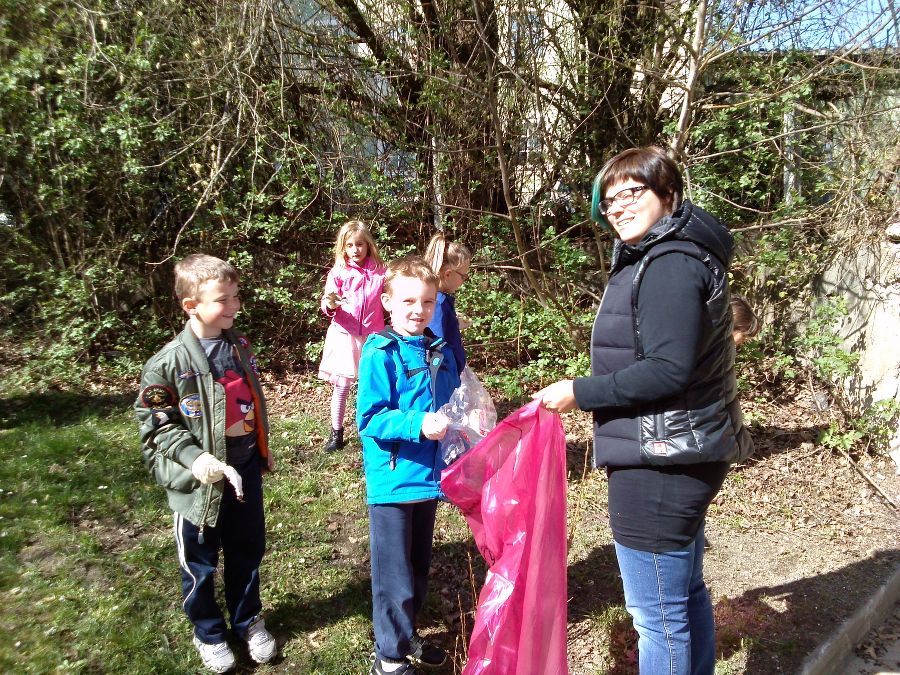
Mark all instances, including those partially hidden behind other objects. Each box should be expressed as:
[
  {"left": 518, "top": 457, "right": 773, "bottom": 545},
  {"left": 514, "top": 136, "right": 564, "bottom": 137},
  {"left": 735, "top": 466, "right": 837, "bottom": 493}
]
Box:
[{"left": 356, "top": 329, "right": 459, "bottom": 504}]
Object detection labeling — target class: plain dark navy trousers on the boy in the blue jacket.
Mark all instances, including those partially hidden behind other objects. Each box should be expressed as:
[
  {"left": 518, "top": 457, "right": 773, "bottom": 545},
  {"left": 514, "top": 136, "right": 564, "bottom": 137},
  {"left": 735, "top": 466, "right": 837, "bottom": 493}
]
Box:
[{"left": 369, "top": 499, "right": 437, "bottom": 661}]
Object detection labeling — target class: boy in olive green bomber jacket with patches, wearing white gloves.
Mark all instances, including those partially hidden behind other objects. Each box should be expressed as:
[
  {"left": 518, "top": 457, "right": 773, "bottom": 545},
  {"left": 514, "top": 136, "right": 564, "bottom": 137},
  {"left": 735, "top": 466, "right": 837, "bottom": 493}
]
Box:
[{"left": 134, "top": 254, "right": 277, "bottom": 673}]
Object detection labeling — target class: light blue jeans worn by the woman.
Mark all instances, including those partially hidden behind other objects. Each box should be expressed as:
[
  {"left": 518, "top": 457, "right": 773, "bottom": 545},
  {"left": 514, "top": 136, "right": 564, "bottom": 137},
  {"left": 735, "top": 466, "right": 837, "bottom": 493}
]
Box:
[{"left": 615, "top": 526, "right": 716, "bottom": 675}]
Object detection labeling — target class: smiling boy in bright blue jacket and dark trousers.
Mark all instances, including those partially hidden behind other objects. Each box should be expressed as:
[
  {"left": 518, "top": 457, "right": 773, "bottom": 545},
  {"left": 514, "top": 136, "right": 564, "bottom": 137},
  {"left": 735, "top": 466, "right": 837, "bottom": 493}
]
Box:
[{"left": 356, "top": 257, "right": 459, "bottom": 675}]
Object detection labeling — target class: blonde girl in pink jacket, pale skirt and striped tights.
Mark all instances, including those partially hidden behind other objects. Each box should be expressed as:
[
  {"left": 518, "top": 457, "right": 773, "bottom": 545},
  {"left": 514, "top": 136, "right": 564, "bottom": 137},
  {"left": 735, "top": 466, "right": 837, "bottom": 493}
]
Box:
[{"left": 319, "top": 220, "right": 385, "bottom": 452}]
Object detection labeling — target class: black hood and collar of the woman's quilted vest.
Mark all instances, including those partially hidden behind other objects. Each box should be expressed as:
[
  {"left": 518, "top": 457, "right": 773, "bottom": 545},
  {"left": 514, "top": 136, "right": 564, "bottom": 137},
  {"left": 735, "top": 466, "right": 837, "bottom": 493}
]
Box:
[{"left": 613, "top": 200, "right": 734, "bottom": 269}]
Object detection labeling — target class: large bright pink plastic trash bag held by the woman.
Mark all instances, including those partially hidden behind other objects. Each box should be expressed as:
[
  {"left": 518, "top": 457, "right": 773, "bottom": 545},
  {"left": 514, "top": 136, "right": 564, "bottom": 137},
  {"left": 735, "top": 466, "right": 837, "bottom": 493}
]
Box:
[{"left": 441, "top": 401, "right": 568, "bottom": 675}]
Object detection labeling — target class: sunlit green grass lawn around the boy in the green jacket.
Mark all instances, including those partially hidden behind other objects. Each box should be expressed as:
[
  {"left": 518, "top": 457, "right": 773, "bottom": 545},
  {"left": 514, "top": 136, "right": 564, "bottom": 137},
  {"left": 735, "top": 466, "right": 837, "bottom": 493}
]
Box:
[{"left": 0, "top": 394, "right": 486, "bottom": 674}]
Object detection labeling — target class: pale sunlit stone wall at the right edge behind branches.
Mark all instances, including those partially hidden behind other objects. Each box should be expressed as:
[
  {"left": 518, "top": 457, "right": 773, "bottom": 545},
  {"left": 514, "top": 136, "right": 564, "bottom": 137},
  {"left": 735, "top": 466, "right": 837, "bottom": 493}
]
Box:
[{"left": 815, "top": 223, "right": 900, "bottom": 453}]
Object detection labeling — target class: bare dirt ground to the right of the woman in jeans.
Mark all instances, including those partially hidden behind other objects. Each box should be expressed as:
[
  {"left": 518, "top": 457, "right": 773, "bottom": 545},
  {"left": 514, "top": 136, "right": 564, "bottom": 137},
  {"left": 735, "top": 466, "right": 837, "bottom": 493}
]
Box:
[{"left": 706, "top": 391, "right": 900, "bottom": 673}]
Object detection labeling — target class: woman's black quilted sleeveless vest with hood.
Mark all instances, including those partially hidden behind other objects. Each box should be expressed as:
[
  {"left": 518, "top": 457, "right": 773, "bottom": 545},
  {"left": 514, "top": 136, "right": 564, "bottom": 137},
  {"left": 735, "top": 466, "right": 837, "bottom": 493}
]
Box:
[{"left": 591, "top": 201, "right": 753, "bottom": 467}]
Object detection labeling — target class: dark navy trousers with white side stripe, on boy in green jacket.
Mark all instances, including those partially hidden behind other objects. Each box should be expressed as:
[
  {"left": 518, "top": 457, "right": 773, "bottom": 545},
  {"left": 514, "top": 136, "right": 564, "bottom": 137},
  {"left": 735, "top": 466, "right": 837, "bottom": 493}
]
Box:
[{"left": 175, "top": 455, "right": 266, "bottom": 644}]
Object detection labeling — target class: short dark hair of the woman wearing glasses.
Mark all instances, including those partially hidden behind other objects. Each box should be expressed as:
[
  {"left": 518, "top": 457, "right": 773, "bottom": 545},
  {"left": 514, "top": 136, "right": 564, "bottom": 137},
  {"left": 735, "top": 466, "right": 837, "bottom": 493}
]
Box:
[{"left": 600, "top": 146, "right": 684, "bottom": 209}]
